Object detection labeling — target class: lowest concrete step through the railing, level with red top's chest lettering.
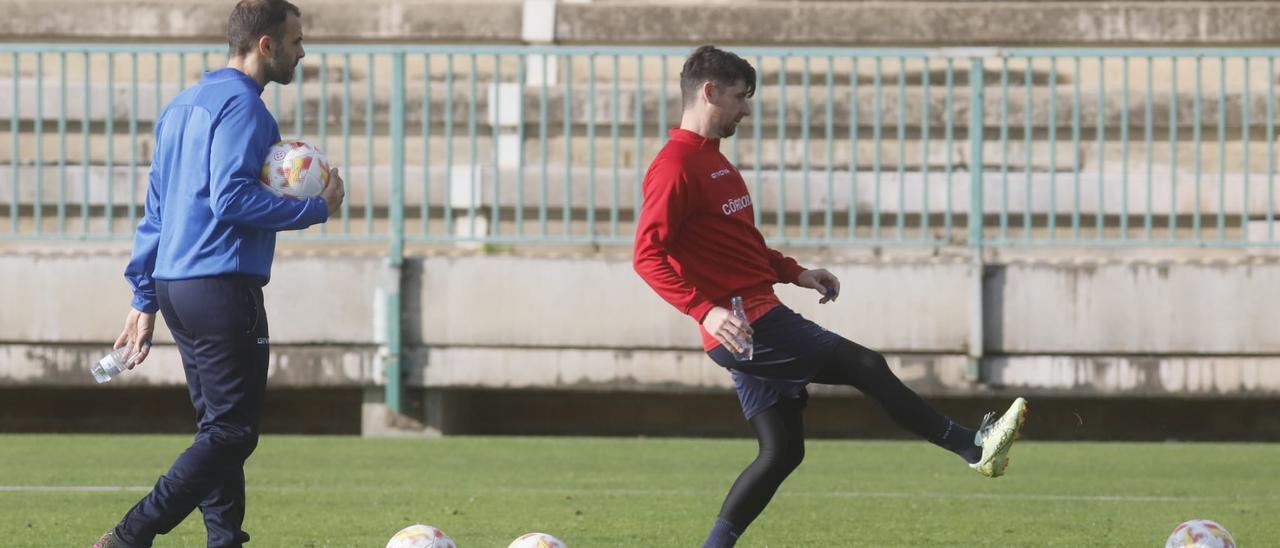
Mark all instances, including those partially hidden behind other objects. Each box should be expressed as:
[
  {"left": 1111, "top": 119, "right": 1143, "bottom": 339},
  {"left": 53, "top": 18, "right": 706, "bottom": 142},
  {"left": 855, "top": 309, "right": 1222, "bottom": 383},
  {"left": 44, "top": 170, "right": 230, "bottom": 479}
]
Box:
[{"left": 0, "top": 165, "right": 1277, "bottom": 219}]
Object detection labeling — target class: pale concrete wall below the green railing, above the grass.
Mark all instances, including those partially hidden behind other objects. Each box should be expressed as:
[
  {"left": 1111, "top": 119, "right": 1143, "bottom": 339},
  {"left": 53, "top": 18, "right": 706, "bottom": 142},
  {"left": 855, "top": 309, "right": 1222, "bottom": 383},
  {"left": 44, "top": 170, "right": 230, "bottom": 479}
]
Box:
[{"left": 0, "top": 248, "right": 1280, "bottom": 431}]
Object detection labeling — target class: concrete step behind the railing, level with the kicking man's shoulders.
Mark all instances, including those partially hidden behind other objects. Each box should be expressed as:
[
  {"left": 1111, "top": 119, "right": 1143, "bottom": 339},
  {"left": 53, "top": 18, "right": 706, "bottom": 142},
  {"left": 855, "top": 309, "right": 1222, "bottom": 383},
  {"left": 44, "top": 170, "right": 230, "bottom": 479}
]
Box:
[{"left": 0, "top": 124, "right": 1280, "bottom": 180}]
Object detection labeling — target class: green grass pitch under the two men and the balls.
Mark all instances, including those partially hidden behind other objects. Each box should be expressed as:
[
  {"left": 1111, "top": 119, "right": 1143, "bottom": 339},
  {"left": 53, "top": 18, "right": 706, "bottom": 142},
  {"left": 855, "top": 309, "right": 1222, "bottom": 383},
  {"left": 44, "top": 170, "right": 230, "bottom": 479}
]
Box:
[{"left": 0, "top": 435, "right": 1280, "bottom": 548}]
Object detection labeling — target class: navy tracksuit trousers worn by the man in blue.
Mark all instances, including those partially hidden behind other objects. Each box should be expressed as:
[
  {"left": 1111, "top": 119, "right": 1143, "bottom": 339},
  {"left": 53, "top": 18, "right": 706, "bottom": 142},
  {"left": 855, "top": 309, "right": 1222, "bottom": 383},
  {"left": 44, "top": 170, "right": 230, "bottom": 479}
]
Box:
[{"left": 115, "top": 275, "right": 270, "bottom": 548}]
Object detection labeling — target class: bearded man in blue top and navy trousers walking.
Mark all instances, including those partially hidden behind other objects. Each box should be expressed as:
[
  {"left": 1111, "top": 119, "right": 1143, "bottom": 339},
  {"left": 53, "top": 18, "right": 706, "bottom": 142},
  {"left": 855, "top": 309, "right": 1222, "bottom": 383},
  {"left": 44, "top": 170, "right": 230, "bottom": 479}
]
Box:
[{"left": 95, "top": 0, "right": 343, "bottom": 548}]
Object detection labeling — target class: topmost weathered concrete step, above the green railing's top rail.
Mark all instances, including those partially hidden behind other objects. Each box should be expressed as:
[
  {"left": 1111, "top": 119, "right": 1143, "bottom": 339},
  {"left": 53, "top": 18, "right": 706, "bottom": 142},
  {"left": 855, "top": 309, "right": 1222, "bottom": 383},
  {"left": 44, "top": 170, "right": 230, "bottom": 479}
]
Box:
[{"left": 0, "top": 0, "right": 1280, "bottom": 45}]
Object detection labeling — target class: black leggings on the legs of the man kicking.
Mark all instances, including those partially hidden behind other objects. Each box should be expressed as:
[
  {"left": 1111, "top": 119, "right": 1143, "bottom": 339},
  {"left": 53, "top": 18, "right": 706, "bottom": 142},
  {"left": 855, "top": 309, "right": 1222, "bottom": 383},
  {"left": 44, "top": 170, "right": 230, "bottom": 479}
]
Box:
[{"left": 719, "top": 338, "right": 948, "bottom": 530}]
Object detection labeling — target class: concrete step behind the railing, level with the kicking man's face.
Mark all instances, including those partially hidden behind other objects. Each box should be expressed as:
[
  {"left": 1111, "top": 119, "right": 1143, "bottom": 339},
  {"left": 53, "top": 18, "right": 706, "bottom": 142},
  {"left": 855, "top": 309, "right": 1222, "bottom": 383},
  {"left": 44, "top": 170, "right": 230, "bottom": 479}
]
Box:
[{"left": 0, "top": 74, "right": 1280, "bottom": 134}]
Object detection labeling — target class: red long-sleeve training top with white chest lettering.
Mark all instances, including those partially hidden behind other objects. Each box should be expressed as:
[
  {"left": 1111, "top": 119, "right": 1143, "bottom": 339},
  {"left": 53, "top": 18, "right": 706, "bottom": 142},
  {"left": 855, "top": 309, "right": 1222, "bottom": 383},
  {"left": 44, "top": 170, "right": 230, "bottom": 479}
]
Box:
[{"left": 632, "top": 129, "right": 805, "bottom": 350}]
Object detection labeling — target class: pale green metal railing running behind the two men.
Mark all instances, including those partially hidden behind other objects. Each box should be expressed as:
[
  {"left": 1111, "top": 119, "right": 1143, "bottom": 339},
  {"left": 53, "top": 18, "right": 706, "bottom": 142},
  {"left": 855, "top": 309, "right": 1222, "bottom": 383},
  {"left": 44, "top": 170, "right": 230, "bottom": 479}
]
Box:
[{"left": 0, "top": 44, "right": 1280, "bottom": 248}]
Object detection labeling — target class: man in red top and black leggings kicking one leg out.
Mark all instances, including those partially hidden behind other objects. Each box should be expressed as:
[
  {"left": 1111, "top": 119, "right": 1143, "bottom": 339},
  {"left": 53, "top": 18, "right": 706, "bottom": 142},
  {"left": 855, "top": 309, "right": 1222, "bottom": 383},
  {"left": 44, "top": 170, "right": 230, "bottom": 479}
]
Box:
[{"left": 634, "top": 46, "right": 1027, "bottom": 547}]
